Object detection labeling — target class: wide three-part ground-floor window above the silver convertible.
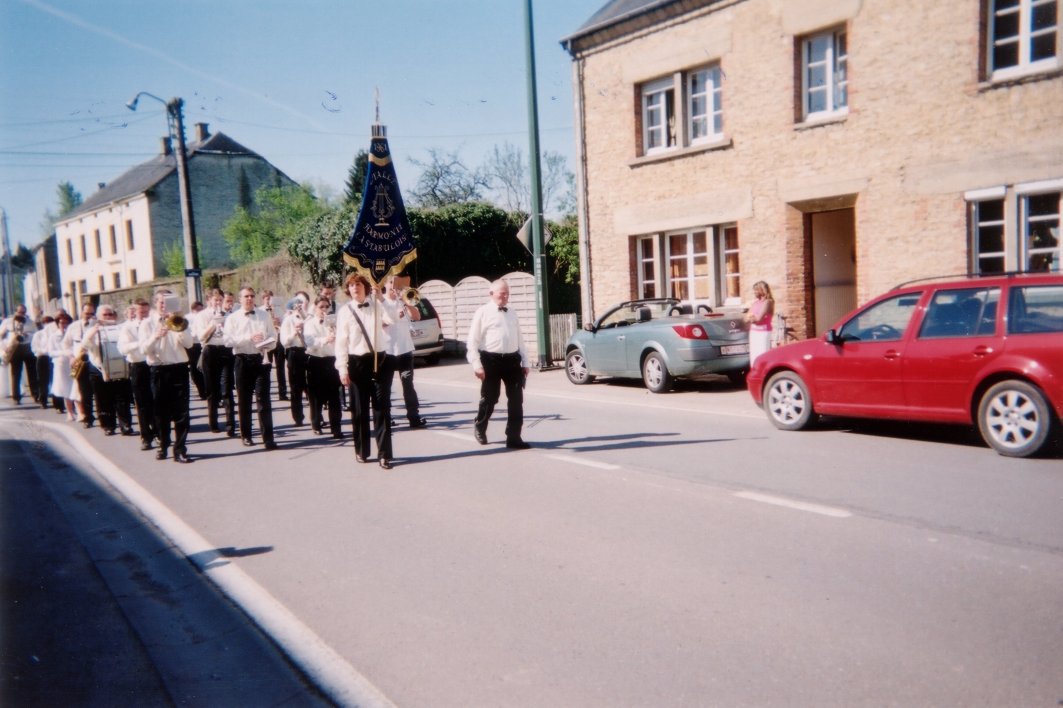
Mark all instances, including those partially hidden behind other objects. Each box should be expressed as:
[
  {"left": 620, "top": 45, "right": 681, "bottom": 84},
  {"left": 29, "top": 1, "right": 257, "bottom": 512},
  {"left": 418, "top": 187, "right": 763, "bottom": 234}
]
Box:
[{"left": 632, "top": 224, "right": 741, "bottom": 306}]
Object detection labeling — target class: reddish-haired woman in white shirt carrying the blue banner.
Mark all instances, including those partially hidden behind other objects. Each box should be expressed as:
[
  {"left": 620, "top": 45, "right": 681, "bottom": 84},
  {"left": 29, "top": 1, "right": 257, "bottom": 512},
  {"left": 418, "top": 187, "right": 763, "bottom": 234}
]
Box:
[{"left": 336, "top": 273, "right": 394, "bottom": 470}]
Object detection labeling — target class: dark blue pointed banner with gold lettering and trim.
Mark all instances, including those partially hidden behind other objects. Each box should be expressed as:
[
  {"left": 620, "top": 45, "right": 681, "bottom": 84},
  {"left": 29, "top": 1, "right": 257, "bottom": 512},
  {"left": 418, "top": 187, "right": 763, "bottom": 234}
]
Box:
[{"left": 343, "top": 123, "right": 417, "bottom": 286}]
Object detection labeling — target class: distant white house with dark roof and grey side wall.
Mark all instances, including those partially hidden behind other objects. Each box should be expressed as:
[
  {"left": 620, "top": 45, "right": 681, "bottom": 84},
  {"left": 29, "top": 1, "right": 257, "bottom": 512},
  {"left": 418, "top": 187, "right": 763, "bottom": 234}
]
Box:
[{"left": 55, "top": 123, "right": 294, "bottom": 311}]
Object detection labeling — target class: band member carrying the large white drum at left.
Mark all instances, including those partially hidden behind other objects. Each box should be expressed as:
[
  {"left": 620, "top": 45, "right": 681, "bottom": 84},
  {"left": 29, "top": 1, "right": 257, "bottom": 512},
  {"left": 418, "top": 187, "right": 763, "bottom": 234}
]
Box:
[{"left": 83, "top": 305, "right": 133, "bottom": 435}]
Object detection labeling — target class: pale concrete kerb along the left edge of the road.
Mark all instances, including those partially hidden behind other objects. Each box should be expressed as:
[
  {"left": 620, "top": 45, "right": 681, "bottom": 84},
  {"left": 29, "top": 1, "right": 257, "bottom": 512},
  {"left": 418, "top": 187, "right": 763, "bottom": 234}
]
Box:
[{"left": 9, "top": 420, "right": 394, "bottom": 708}]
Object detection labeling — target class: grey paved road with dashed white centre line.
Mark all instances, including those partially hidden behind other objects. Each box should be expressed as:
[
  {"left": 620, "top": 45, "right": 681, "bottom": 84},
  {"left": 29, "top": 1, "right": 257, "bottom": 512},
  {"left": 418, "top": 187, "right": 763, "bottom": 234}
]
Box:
[{"left": 0, "top": 366, "right": 1063, "bottom": 706}]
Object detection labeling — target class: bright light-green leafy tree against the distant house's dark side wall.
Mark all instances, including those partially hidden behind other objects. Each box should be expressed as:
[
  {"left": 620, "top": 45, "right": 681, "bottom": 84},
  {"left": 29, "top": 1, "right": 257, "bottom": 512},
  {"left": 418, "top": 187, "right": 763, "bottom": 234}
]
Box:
[{"left": 221, "top": 185, "right": 326, "bottom": 265}]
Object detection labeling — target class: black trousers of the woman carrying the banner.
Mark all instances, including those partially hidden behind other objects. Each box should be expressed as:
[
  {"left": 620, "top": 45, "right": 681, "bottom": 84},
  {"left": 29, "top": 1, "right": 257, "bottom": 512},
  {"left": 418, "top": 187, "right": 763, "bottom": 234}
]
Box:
[{"left": 347, "top": 354, "right": 394, "bottom": 459}]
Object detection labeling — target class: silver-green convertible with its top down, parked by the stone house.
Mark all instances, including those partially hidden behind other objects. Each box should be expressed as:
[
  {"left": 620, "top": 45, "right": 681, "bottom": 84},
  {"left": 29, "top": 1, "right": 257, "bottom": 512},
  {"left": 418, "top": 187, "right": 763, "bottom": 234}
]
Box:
[{"left": 564, "top": 299, "right": 749, "bottom": 393}]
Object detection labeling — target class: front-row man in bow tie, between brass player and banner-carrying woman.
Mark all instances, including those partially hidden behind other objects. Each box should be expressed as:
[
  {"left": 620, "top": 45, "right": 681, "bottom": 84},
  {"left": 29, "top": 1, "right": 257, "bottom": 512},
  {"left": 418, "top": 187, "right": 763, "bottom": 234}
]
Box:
[{"left": 224, "top": 287, "right": 277, "bottom": 450}]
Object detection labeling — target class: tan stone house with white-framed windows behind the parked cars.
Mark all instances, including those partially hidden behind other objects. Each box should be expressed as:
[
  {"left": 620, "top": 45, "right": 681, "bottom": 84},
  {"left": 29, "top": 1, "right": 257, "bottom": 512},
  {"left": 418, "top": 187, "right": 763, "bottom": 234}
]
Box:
[{"left": 561, "top": 0, "right": 1063, "bottom": 337}]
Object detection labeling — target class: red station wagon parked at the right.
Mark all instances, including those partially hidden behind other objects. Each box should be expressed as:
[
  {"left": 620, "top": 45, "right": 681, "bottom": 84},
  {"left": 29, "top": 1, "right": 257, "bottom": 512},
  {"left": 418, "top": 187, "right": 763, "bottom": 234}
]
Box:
[{"left": 746, "top": 273, "right": 1063, "bottom": 457}]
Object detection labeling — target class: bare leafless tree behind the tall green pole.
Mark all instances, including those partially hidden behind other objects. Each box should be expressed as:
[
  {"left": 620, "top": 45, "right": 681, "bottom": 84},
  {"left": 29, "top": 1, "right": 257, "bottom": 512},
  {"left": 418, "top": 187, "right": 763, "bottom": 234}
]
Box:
[{"left": 484, "top": 142, "right": 572, "bottom": 214}]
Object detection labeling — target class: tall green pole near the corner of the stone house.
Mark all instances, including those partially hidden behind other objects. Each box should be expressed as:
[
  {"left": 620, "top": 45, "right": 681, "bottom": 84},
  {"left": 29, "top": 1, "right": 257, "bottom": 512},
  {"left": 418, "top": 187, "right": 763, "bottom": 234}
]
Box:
[{"left": 524, "top": 0, "right": 553, "bottom": 370}]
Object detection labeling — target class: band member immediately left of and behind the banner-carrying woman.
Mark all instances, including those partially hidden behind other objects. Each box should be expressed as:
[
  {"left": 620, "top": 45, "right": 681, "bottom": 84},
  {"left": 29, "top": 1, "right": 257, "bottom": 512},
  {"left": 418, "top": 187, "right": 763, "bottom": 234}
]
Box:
[{"left": 301, "top": 297, "right": 343, "bottom": 440}]
